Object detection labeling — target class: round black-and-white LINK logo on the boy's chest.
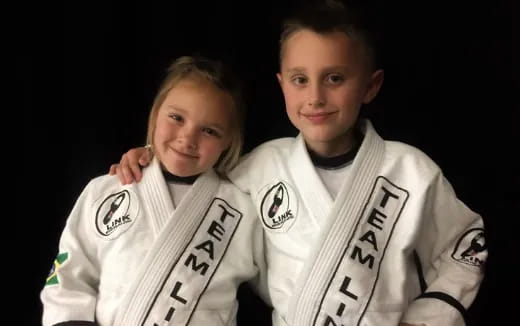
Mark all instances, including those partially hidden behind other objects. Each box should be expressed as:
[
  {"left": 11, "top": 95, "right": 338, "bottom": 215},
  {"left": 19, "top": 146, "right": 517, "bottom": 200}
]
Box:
[{"left": 260, "top": 181, "right": 298, "bottom": 232}]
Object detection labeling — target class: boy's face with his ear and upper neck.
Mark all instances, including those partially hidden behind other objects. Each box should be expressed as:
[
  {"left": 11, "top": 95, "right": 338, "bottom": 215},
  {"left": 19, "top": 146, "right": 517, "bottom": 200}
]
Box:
[{"left": 277, "top": 29, "right": 383, "bottom": 156}]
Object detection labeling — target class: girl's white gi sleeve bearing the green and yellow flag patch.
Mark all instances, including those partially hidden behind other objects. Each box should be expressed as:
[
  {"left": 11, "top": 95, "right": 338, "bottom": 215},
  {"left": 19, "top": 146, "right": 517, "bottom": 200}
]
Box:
[{"left": 40, "top": 183, "right": 99, "bottom": 326}]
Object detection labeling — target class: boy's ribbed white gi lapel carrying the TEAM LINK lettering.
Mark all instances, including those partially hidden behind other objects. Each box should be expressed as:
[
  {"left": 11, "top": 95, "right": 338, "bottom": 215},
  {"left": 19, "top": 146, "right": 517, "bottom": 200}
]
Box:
[{"left": 288, "top": 121, "right": 406, "bottom": 326}]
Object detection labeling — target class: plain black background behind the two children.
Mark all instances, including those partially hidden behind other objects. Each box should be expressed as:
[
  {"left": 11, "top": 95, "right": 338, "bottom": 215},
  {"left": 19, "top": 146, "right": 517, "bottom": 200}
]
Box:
[{"left": 21, "top": 0, "right": 520, "bottom": 325}]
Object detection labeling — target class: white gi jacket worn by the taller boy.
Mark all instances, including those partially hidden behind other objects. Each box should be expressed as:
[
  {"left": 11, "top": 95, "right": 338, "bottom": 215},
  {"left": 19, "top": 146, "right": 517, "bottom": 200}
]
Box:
[{"left": 231, "top": 121, "right": 487, "bottom": 326}]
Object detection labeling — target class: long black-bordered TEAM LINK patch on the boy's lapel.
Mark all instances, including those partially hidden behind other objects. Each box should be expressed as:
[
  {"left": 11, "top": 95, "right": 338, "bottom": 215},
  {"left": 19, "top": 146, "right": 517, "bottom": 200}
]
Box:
[{"left": 314, "top": 176, "right": 409, "bottom": 326}]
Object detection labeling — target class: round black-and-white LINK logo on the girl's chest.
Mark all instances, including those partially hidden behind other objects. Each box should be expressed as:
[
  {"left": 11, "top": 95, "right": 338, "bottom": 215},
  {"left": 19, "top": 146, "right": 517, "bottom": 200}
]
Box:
[{"left": 96, "top": 190, "right": 138, "bottom": 239}]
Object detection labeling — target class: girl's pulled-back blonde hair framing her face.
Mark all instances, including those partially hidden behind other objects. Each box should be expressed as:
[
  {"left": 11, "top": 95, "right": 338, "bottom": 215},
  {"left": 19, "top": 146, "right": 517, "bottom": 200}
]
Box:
[{"left": 146, "top": 56, "right": 245, "bottom": 176}]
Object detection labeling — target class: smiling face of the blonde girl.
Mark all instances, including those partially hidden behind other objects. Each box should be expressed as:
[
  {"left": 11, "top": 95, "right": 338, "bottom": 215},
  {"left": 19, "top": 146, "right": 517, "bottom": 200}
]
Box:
[{"left": 153, "top": 78, "right": 233, "bottom": 177}]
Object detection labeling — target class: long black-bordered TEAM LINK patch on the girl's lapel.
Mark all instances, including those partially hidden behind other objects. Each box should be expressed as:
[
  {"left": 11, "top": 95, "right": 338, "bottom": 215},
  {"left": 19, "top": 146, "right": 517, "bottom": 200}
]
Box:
[{"left": 142, "top": 198, "right": 242, "bottom": 326}]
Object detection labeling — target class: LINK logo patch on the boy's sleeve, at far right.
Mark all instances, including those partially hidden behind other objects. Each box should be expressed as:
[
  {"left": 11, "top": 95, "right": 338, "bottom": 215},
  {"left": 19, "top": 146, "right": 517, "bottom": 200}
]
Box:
[{"left": 451, "top": 228, "right": 487, "bottom": 266}]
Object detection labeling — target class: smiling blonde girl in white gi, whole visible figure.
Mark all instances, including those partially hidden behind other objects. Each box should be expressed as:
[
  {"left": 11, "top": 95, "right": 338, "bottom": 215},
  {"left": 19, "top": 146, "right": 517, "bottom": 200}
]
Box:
[{"left": 41, "top": 57, "right": 264, "bottom": 326}]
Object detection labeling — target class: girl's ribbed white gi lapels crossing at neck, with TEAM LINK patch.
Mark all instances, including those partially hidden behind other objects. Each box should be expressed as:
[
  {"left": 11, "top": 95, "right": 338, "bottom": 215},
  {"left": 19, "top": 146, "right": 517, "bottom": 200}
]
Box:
[{"left": 114, "top": 163, "right": 242, "bottom": 326}]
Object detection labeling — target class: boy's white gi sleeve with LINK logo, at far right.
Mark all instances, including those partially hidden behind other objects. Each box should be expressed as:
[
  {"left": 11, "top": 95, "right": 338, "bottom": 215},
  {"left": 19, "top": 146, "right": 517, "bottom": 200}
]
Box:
[{"left": 402, "top": 172, "right": 487, "bottom": 326}]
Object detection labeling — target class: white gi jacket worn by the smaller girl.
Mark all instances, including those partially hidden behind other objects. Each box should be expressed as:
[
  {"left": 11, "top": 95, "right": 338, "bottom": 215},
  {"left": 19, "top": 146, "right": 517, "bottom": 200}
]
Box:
[{"left": 41, "top": 160, "right": 264, "bottom": 326}]
